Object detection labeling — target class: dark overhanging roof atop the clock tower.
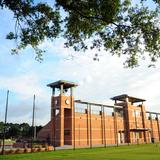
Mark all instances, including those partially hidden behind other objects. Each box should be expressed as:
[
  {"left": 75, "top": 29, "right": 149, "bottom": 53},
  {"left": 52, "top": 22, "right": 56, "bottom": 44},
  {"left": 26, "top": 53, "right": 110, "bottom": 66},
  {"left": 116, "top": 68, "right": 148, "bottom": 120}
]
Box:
[{"left": 47, "top": 80, "right": 78, "bottom": 89}]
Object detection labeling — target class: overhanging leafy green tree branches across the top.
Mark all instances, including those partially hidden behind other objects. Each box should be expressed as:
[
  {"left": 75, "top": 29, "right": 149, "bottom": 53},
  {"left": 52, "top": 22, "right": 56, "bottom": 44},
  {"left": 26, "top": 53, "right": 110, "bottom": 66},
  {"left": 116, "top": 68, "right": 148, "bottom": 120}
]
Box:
[{"left": 0, "top": 0, "right": 160, "bottom": 67}]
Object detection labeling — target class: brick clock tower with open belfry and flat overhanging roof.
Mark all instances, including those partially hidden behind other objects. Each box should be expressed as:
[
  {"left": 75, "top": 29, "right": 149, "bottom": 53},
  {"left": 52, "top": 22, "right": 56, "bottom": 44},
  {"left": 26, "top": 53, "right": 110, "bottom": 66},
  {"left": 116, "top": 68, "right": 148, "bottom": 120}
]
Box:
[{"left": 47, "top": 80, "right": 77, "bottom": 146}]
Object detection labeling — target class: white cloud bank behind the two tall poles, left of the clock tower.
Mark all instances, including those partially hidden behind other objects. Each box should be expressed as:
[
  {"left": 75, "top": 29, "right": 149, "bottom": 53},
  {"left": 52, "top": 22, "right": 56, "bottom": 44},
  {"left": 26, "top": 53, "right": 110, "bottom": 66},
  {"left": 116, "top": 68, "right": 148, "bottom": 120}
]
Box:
[{"left": 0, "top": 73, "right": 50, "bottom": 125}]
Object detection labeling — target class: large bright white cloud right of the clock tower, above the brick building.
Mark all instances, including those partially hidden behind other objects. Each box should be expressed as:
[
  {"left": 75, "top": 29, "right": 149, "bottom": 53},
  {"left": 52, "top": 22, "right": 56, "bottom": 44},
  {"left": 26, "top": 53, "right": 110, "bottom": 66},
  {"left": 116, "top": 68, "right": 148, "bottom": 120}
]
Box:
[{"left": 50, "top": 45, "right": 160, "bottom": 111}]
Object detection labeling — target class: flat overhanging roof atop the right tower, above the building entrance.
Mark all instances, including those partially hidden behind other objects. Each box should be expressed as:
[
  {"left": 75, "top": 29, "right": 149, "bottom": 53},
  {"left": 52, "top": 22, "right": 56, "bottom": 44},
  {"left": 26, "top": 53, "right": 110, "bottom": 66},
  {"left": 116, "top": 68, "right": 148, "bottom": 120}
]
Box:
[{"left": 111, "top": 94, "right": 146, "bottom": 103}]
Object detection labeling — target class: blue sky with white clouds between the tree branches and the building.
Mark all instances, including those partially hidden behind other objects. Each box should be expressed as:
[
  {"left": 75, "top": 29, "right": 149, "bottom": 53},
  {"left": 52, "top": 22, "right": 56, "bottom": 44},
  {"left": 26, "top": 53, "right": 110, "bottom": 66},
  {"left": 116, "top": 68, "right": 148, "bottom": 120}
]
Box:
[{"left": 0, "top": 0, "right": 160, "bottom": 124}]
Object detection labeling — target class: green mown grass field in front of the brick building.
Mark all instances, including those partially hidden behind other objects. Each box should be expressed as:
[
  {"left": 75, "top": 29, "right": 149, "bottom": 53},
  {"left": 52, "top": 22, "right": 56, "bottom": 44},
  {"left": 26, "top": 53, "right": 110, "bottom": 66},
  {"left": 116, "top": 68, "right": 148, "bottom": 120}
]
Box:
[{"left": 0, "top": 144, "right": 160, "bottom": 160}]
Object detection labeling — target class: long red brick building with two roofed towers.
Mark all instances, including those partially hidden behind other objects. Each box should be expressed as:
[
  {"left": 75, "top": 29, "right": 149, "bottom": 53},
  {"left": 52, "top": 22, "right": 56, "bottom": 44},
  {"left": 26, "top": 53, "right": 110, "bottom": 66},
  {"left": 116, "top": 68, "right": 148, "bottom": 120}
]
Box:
[{"left": 37, "top": 80, "right": 160, "bottom": 147}]
